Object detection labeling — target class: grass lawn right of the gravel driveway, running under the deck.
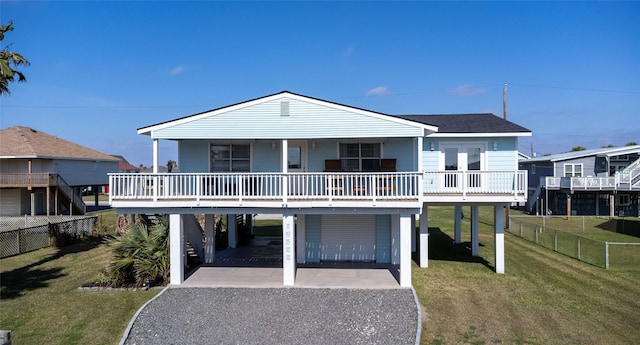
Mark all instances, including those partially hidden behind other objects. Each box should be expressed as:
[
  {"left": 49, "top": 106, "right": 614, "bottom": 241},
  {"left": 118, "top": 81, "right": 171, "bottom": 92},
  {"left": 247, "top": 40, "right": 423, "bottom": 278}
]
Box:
[{"left": 413, "top": 207, "right": 640, "bottom": 344}]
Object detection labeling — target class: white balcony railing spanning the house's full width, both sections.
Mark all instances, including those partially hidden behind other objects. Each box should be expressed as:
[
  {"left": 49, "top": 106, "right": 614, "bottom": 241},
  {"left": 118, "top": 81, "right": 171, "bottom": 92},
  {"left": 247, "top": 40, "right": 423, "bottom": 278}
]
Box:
[{"left": 109, "top": 171, "right": 527, "bottom": 203}]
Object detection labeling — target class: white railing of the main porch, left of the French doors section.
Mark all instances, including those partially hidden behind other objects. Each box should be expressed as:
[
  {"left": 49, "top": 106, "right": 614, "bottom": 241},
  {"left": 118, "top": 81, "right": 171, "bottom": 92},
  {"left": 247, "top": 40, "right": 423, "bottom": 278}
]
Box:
[{"left": 109, "top": 172, "right": 421, "bottom": 202}]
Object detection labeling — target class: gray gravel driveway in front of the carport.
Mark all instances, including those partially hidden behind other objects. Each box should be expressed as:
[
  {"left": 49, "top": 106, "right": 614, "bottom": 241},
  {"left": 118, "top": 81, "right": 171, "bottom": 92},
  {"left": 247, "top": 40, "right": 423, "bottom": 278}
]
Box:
[{"left": 125, "top": 288, "right": 418, "bottom": 345}]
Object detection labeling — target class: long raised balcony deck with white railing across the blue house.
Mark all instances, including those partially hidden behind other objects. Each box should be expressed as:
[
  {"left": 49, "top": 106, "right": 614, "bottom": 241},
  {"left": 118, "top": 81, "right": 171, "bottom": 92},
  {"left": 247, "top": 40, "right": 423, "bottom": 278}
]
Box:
[{"left": 109, "top": 171, "right": 527, "bottom": 208}]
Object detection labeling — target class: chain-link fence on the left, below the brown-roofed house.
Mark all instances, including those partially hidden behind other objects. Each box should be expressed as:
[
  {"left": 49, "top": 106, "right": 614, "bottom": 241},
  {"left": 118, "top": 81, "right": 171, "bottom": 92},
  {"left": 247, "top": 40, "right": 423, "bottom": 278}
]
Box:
[{"left": 0, "top": 216, "right": 98, "bottom": 258}]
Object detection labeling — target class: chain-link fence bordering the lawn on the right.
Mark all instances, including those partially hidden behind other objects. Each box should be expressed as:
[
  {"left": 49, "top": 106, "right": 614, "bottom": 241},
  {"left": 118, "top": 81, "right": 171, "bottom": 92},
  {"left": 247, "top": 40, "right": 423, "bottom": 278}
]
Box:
[{"left": 507, "top": 217, "right": 640, "bottom": 269}]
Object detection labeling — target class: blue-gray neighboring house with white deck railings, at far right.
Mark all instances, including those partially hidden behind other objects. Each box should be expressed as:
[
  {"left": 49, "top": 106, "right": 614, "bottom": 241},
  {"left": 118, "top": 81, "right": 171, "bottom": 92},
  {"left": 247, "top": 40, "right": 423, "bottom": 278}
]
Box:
[{"left": 519, "top": 145, "right": 640, "bottom": 217}]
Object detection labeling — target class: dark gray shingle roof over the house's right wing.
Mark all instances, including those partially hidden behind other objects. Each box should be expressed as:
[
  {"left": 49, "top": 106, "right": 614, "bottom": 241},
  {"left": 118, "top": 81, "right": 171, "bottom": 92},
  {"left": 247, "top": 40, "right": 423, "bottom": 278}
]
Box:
[{"left": 398, "top": 113, "right": 531, "bottom": 133}]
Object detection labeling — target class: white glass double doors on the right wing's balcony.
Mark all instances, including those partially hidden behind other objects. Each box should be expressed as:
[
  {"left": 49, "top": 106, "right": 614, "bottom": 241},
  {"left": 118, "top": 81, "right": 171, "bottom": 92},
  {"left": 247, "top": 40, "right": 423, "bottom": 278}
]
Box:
[{"left": 441, "top": 144, "right": 485, "bottom": 189}]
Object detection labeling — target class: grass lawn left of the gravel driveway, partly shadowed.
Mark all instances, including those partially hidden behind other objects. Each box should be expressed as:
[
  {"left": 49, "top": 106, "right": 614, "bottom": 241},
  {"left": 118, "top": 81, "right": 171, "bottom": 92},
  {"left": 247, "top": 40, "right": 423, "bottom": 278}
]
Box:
[{"left": 0, "top": 237, "right": 159, "bottom": 344}]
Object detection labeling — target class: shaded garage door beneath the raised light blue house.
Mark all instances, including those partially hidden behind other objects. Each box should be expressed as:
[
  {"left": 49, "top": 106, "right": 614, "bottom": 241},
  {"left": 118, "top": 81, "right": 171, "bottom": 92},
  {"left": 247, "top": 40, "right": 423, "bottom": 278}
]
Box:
[{"left": 320, "top": 215, "right": 376, "bottom": 262}]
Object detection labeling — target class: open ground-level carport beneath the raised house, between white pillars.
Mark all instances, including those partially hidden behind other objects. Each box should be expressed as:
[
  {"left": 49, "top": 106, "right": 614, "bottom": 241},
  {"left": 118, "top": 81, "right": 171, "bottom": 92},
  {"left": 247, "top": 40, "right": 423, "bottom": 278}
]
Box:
[{"left": 159, "top": 208, "right": 419, "bottom": 287}]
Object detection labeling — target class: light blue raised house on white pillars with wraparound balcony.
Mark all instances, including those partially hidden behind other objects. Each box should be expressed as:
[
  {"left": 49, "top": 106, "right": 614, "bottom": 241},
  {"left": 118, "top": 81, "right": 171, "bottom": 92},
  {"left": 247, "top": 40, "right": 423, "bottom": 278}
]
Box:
[{"left": 110, "top": 91, "right": 531, "bottom": 287}]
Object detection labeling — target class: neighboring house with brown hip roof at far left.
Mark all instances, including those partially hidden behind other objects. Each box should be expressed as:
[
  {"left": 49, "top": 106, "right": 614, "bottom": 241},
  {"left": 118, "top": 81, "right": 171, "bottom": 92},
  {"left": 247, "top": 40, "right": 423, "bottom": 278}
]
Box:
[{"left": 0, "top": 126, "right": 118, "bottom": 216}]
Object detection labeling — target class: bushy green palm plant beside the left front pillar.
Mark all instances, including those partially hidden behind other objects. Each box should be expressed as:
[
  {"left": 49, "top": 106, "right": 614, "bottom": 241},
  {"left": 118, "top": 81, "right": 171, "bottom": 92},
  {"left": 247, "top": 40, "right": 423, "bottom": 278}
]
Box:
[{"left": 107, "top": 219, "right": 169, "bottom": 286}]
